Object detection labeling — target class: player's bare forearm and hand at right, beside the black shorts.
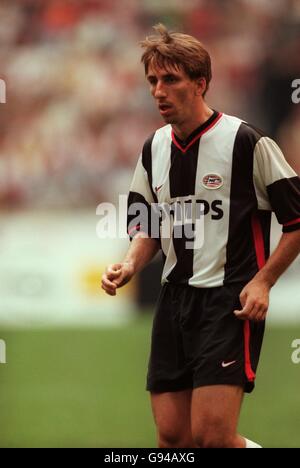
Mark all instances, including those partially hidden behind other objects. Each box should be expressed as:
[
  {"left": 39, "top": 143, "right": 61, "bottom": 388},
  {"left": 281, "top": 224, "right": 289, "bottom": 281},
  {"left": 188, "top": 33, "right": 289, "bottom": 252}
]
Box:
[{"left": 234, "top": 230, "right": 300, "bottom": 321}]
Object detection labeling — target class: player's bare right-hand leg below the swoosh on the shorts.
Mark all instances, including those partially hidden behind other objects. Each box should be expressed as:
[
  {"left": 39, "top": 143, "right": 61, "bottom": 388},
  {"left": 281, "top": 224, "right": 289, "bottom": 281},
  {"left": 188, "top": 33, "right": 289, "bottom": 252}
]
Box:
[{"left": 192, "top": 385, "right": 246, "bottom": 448}]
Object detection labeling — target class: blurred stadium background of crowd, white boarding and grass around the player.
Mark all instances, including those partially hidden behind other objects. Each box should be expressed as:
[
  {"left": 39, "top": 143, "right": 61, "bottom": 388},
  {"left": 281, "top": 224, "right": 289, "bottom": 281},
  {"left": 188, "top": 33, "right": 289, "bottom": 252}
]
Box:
[{"left": 0, "top": 0, "right": 300, "bottom": 447}]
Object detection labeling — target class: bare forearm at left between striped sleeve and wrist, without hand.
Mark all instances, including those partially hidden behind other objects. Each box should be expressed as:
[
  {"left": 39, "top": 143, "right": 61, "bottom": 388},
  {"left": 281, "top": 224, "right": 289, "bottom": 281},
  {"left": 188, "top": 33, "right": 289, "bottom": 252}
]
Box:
[{"left": 124, "top": 233, "right": 160, "bottom": 274}]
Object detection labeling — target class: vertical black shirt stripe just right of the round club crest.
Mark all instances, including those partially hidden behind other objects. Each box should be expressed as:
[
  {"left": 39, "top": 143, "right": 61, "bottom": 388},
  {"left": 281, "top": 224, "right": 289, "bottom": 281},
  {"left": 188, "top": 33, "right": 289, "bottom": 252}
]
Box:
[{"left": 224, "top": 123, "right": 264, "bottom": 283}]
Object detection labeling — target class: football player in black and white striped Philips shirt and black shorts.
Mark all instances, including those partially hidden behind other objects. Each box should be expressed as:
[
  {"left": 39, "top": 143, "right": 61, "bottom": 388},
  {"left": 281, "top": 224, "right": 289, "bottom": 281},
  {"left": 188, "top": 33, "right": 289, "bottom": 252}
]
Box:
[{"left": 102, "top": 25, "right": 300, "bottom": 448}]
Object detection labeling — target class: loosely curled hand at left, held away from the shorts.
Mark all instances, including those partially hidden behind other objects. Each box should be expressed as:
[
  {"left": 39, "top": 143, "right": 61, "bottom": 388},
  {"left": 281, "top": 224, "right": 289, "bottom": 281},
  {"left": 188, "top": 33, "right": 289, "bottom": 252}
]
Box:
[{"left": 101, "top": 262, "right": 134, "bottom": 296}]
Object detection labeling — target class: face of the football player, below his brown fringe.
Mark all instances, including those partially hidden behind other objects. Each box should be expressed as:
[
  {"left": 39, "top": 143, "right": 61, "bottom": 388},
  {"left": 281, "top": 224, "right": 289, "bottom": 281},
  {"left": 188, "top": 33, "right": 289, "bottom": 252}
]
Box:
[{"left": 147, "top": 63, "right": 205, "bottom": 125}]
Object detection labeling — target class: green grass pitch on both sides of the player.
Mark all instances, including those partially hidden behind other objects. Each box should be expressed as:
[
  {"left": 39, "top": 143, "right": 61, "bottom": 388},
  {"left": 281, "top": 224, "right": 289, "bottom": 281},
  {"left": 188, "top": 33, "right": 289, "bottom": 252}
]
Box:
[{"left": 0, "top": 317, "right": 300, "bottom": 447}]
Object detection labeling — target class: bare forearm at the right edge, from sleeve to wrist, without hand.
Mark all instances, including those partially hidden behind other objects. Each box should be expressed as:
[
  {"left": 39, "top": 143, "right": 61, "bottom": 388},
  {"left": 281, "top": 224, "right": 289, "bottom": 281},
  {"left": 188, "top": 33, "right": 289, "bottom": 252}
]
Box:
[{"left": 254, "top": 231, "right": 300, "bottom": 287}]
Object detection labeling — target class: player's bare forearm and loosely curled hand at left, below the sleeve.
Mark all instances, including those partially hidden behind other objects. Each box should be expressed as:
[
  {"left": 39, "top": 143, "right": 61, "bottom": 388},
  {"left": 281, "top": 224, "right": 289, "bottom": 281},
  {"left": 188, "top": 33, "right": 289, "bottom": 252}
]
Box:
[{"left": 101, "top": 232, "right": 159, "bottom": 296}]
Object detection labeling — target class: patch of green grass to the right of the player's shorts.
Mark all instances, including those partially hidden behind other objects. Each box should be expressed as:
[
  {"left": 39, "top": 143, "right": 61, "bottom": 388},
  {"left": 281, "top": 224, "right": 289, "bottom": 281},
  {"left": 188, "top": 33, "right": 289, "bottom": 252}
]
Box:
[{"left": 240, "top": 325, "right": 300, "bottom": 448}]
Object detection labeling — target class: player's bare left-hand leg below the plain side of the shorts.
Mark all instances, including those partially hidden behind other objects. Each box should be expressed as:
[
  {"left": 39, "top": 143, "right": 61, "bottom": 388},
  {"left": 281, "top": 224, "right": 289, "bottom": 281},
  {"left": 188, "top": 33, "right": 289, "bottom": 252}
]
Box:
[{"left": 151, "top": 390, "right": 195, "bottom": 448}]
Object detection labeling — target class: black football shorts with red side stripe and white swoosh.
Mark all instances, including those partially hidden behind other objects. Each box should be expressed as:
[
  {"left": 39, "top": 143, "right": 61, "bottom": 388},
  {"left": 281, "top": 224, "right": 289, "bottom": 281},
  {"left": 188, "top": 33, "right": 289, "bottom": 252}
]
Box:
[{"left": 147, "top": 283, "right": 265, "bottom": 393}]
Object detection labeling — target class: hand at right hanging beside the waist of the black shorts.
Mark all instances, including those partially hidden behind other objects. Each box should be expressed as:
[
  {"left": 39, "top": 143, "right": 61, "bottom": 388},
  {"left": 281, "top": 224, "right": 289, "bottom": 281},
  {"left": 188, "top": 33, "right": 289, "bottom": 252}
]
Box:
[{"left": 234, "top": 280, "right": 271, "bottom": 322}]
